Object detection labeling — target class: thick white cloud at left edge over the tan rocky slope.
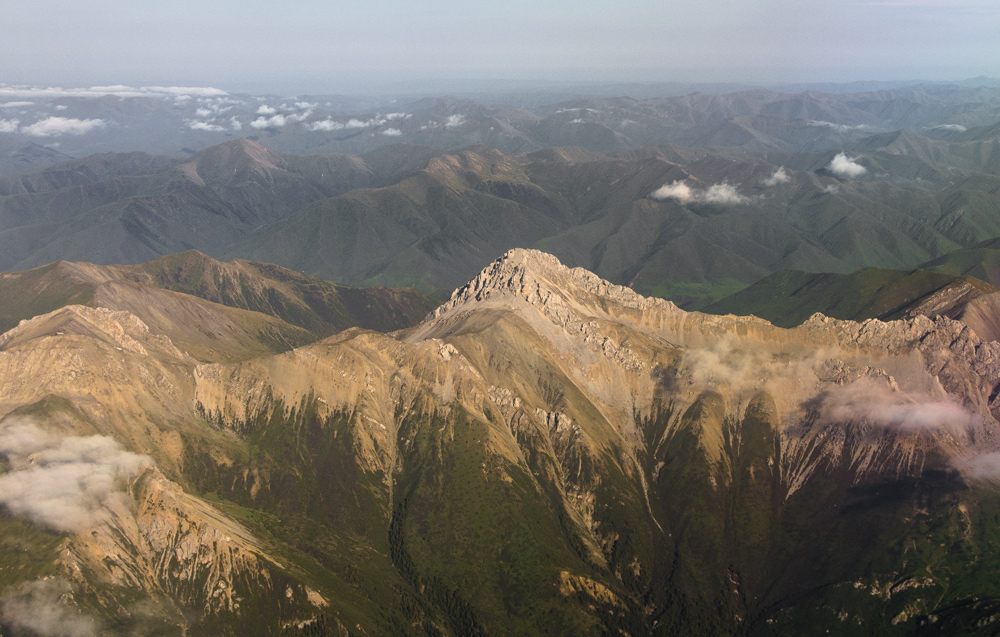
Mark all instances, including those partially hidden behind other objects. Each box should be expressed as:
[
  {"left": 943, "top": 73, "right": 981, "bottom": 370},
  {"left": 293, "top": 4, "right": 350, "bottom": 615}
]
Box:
[{"left": 0, "top": 419, "right": 150, "bottom": 532}]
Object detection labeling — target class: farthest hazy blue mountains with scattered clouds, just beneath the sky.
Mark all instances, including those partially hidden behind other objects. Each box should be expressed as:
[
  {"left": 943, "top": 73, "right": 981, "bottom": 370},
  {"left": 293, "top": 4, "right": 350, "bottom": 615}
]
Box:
[{"left": 0, "top": 78, "right": 1000, "bottom": 161}]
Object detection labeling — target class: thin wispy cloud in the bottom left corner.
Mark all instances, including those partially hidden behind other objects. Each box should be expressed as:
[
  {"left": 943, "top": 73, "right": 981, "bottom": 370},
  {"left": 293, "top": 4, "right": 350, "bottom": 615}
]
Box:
[{"left": 0, "top": 578, "right": 101, "bottom": 637}]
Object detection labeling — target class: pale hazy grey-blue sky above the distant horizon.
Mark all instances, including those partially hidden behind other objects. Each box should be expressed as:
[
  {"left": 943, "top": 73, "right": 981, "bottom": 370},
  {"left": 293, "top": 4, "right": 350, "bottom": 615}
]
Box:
[{"left": 0, "top": 0, "right": 1000, "bottom": 92}]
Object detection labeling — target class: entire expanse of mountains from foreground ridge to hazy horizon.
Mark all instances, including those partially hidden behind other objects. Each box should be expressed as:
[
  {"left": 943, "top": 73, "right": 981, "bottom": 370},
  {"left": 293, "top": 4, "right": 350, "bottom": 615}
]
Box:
[{"left": 0, "top": 79, "right": 1000, "bottom": 637}]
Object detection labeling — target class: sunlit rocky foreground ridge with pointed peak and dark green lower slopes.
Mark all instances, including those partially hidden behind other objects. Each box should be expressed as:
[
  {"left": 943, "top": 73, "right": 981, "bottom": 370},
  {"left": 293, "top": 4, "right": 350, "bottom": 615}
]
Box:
[{"left": 0, "top": 250, "right": 1000, "bottom": 635}]
